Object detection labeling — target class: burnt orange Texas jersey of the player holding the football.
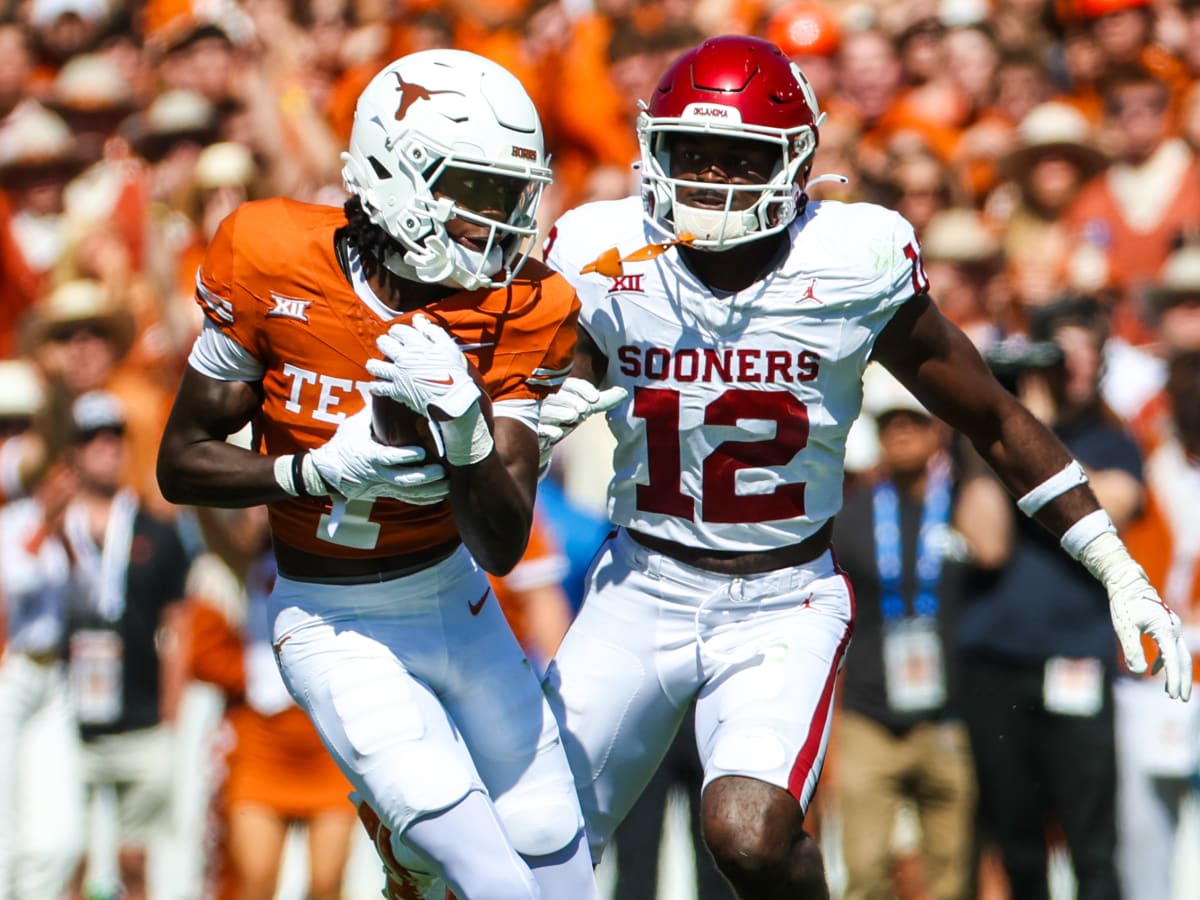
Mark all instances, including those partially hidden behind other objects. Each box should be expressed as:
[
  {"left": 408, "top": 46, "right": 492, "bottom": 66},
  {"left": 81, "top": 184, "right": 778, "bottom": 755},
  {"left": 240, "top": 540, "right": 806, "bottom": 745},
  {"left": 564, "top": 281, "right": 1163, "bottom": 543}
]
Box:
[{"left": 196, "top": 199, "right": 578, "bottom": 558}]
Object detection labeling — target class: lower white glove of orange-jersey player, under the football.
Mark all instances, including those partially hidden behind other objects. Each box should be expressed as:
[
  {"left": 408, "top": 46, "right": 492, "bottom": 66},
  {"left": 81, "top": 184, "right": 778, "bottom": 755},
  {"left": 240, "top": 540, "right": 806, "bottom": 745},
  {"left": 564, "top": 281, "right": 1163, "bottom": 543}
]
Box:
[{"left": 308, "top": 406, "right": 450, "bottom": 506}]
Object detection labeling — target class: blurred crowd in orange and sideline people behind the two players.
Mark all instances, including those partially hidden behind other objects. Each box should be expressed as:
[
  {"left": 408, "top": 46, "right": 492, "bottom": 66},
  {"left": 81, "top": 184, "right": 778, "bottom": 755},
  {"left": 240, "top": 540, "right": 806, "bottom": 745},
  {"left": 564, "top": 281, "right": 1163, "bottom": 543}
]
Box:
[{"left": 0, "top": 0, "right": 1200, "bottom": 900}]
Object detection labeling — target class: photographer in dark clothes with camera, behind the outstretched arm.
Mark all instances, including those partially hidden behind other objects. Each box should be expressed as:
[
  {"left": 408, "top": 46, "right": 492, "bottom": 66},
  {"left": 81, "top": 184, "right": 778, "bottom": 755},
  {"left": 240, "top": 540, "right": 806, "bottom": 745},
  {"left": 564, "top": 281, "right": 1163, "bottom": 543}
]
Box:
[{"left": 959, "top": 296, "right": 1142, "bottom": 900}]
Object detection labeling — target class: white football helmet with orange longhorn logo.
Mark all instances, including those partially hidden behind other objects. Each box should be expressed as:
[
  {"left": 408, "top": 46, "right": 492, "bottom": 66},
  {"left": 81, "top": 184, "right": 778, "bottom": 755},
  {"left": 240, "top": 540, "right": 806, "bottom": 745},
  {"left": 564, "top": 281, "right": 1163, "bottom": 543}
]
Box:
[{"left": 342, "top": 49, "right": 551, "bottom": 290}]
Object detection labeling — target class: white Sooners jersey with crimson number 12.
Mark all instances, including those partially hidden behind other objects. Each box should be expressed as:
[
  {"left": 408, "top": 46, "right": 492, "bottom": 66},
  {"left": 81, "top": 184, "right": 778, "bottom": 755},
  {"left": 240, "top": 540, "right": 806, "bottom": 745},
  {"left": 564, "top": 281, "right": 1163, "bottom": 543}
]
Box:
[{"left": 546, "top": 197, "right": 928, "bottom": 551}]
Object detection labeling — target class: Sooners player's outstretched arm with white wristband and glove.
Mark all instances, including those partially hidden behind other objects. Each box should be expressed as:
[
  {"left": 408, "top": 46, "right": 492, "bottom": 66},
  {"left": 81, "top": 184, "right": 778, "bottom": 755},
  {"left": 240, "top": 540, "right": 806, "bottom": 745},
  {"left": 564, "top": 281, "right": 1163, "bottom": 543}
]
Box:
[{"left": 874, "top": 294, "right": 1192, "bottom": 700}]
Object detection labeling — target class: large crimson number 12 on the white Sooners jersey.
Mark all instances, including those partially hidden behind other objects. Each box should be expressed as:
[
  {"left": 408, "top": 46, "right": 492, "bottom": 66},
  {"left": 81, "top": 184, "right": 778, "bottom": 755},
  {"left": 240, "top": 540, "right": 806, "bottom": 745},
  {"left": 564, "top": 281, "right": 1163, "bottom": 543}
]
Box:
[{"left": 634, "top": 388, "right": 809, "bottom": 524}]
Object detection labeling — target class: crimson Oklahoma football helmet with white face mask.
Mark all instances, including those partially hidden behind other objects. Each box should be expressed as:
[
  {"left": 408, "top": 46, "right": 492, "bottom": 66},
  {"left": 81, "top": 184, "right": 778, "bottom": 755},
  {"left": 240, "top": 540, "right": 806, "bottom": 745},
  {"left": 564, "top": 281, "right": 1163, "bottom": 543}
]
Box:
[{"left": 637, "top": 35, "right": 824, "bottom": 250}]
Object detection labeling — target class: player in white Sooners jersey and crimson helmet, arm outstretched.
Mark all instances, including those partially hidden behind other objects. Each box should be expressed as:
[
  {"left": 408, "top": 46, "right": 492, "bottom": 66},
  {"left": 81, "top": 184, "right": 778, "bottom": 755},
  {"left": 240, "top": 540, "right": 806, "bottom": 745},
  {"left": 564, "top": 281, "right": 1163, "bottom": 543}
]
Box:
[{"left": 540, "top": 36, "right": 1192, "bottom": 900}]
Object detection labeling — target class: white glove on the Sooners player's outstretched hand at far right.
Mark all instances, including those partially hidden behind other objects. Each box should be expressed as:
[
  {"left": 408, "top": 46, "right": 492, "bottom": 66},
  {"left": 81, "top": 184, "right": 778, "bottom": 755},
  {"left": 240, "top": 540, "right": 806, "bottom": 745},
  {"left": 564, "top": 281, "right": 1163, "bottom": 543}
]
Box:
[{"left": 1079, "top": 532, "right": 1192, "bottom": 701}]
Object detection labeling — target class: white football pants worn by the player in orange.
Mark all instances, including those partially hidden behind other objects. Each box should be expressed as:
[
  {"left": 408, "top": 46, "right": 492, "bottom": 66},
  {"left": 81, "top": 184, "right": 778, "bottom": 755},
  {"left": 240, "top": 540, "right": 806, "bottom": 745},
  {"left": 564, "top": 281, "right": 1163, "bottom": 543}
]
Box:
[{"left": 269, "top": 547, "right": 582, "bottom": 863}]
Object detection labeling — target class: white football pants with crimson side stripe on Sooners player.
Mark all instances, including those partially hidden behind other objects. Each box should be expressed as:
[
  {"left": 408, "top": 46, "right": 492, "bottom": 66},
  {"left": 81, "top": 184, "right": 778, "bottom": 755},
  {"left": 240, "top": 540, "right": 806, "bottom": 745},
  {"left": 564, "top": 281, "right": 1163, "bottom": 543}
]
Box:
[{"left": 545, "top": 530, "right": 853, "bottom": 860}]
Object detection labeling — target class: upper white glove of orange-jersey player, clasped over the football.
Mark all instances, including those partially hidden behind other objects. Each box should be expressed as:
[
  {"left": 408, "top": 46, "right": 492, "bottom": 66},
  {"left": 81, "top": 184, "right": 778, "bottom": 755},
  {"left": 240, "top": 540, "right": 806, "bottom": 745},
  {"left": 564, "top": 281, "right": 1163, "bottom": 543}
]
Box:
[{"left": 367, "top": 316, "right": 494, "bottom": 466}]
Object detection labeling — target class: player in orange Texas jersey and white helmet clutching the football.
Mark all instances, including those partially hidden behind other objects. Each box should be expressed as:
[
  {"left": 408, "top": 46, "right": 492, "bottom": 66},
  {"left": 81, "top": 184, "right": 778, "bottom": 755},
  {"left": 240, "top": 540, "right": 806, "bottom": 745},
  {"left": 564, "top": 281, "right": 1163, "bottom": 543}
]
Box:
[{"left": 158, "top": 49, "right": 595, "bottom": 900}]
